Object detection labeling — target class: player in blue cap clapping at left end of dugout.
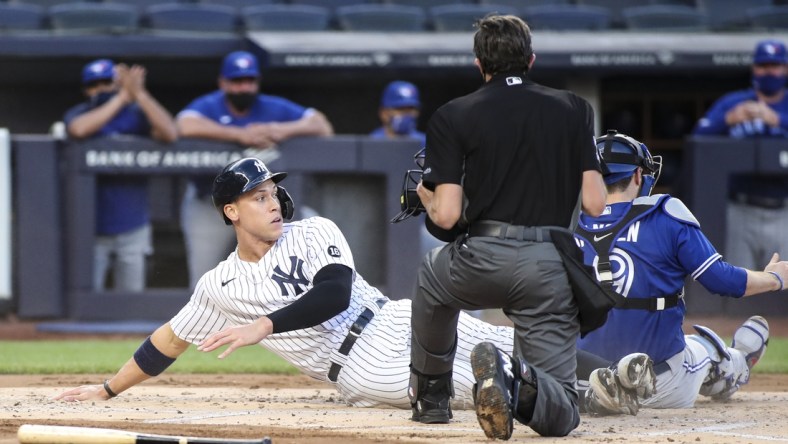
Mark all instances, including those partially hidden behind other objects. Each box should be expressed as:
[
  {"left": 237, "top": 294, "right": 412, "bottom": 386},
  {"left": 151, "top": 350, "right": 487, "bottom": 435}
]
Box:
[{"left": 63, "top": 59, "right": 178, "bottom": 291}]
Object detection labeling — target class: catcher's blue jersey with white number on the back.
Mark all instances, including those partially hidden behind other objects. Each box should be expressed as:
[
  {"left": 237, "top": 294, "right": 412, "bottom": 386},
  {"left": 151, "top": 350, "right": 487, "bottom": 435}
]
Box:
[{"left": 576, "top": 195, "right": 720, "bottom": 362}]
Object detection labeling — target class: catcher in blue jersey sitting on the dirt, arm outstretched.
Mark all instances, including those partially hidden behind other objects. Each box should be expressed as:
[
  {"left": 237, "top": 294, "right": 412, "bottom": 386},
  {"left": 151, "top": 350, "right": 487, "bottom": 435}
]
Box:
[{"left": 576, "top": 131, "right": 788, "bottom": 414}]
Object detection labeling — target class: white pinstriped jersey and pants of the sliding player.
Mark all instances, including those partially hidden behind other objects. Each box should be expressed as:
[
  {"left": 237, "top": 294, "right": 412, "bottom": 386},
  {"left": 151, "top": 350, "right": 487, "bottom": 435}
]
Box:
[{"left": 170, "top": 217, "right": 513, "bottom": 408}]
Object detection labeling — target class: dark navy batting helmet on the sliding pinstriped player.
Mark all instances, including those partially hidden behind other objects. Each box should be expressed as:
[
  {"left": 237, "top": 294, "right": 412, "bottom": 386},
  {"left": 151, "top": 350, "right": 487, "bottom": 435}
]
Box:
[{"left": 212, "top": 157, "right": 293, "bottom": 225}]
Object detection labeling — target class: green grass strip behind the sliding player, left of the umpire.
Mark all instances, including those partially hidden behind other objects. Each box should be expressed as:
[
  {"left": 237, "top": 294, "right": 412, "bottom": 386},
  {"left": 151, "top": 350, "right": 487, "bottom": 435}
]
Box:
[{"left": 0, "top": 339, "right": 298, "bottom": 374}]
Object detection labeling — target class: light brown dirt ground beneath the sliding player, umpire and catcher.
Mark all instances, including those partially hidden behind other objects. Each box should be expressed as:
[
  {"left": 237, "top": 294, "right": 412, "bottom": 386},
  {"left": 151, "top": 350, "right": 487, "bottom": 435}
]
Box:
[{"left": 0, "top": 314, "right": 788, "bottom": 444}]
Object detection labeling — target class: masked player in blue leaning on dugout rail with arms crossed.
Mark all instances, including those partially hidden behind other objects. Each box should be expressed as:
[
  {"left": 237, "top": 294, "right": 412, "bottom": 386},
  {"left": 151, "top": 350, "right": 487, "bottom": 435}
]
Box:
[{"left": 177, "top": 51, "right": 333, "bottom": 286}]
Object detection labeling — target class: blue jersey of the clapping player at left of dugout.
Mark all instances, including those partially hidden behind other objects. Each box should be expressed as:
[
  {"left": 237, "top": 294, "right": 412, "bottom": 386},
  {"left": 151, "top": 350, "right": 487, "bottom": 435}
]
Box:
[{"left": 63, "top": 97, "right": 151, "bottom": 236}]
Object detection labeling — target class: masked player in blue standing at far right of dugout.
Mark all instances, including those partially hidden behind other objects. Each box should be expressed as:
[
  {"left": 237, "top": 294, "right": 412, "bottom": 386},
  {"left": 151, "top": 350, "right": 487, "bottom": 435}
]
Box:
[{"left": 694, "top": 40, "right": 788, "bottom": 269}]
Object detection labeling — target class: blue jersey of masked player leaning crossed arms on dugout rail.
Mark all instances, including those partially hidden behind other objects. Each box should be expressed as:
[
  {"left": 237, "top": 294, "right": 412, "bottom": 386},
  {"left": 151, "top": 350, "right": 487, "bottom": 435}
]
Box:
[{"left": 178, "top": 90, "right": 307, "bottom": 126}]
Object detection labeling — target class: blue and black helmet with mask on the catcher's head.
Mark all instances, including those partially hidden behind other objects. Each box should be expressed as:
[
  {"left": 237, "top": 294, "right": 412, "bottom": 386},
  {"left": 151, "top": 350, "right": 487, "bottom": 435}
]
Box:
[{"left": 595, "top": 130, "right": 662, "bottom": 196}]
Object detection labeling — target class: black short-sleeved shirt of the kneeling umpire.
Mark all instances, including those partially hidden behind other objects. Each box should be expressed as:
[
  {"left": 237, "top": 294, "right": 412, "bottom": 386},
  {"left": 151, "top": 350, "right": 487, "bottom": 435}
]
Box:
[{"left": 423, "top": 73, "right": 600, "bottom": 227}]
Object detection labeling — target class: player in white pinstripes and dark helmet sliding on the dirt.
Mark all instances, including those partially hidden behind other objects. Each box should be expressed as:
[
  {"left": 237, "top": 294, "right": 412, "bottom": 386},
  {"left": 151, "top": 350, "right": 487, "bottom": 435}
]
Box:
[{"left": 56, "top": 158, "right": 528, "bottom": 408}]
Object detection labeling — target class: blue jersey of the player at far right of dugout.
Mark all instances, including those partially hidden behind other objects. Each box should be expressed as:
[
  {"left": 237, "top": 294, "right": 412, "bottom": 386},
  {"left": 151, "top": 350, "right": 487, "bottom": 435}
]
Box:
[{"left": 693, "top": 89, "right": 788, "bottom": 139}]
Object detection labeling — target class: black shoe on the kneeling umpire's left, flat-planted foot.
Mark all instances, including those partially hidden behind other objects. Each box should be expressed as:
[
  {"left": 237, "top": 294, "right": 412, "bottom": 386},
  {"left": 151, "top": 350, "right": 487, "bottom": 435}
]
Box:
[{"left": 408, "top": 368, "right": 454, "bottom": 424}]
